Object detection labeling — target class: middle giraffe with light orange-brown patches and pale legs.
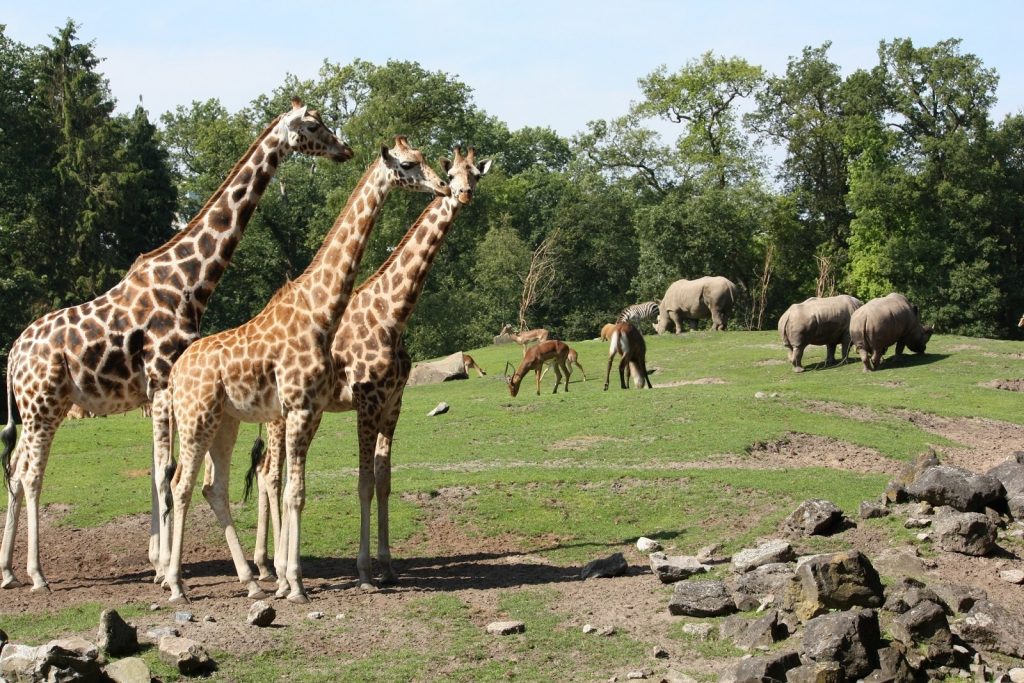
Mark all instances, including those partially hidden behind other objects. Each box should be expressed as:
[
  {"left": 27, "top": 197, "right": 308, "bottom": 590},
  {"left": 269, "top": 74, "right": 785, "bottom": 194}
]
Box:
[{"left": 166, "top": 136, "right": 450, "bottom": 603}]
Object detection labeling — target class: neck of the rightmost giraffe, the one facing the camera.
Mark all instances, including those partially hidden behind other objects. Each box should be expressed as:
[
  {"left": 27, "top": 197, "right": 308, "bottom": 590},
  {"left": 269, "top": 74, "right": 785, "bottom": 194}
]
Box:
[{"left": 359, "top": 197, "right": 462, "bottom": 332}]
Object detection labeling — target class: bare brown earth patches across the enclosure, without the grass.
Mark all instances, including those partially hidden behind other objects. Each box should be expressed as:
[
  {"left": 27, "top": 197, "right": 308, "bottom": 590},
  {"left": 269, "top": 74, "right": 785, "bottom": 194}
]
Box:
[{"left": 0, "top": 409, "right": 1024, "bottom": 680}]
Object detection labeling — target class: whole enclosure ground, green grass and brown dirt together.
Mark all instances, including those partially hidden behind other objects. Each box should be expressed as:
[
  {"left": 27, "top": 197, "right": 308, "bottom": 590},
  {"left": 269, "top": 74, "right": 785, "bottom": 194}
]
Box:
[{"left": 0, "top": 332, "right": 1024, "bottom": 681}]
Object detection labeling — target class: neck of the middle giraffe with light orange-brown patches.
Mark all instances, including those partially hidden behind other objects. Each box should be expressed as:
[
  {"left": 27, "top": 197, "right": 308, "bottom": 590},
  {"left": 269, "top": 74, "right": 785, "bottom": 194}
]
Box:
[{"left": 292, "top": 158, "right": 393, "bottom": 336}]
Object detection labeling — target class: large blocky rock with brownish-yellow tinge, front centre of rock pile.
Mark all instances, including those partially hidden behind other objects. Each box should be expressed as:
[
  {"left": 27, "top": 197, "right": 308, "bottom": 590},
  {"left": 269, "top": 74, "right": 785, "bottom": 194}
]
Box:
[{"left": 787, "top": 550, "right": 883, "bottom": 620}]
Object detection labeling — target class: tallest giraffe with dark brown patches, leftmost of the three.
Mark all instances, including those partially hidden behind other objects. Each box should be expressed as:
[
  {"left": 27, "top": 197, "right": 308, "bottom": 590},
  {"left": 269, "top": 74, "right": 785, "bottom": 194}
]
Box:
[{"left": 0, "top": 99, "right": 352, "bottom": 591}]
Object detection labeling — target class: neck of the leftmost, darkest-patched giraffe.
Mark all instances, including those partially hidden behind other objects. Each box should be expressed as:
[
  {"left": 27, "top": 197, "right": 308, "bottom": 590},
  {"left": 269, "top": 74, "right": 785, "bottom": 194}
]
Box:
[{"left": 126, "top": 117, "right": 291, "bottom": 315}]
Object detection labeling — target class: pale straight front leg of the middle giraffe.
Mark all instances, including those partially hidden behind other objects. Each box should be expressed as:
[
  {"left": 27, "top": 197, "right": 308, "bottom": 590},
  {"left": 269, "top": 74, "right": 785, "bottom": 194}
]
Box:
[{"left": 282, "top": 410, "right": 322, "bottom": 604}]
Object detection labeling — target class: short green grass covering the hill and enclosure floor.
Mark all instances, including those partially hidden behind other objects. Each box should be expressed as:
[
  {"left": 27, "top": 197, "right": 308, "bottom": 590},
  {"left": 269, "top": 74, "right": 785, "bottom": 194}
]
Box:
[{"left": 0, "top": 332, "right": 1024, "bottom": 681}]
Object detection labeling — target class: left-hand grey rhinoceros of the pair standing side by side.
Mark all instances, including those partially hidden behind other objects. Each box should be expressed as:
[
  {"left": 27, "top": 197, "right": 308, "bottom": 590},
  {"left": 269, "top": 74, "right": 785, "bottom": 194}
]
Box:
[{"left": 778, "top": 294, "right": 861, "bottom": 373}]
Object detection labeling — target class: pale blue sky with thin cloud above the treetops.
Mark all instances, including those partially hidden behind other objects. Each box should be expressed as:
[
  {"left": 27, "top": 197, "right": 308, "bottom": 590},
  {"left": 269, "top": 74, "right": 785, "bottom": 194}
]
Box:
[{"left": 0, "top": 0, "right": 1024, "bottom": 136}]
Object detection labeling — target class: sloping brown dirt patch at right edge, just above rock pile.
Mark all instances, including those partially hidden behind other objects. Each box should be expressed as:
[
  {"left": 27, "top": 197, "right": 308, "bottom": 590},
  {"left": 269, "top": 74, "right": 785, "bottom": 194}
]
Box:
[{"left": 894, "top": 411, "right": 1024, "bottom": 472}]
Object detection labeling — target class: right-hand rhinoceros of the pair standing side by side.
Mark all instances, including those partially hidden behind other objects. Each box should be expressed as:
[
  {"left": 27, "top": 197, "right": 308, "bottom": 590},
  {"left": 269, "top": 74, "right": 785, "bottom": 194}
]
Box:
[{"left": 850, "top": 292, "right": 932, "bottom": 373}]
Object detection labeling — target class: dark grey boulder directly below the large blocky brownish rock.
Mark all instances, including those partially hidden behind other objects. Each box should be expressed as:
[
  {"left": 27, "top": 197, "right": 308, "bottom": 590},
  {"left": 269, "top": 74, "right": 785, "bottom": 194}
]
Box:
[{"left": 804, "top": 609, "right": 882, "bottom": 680}]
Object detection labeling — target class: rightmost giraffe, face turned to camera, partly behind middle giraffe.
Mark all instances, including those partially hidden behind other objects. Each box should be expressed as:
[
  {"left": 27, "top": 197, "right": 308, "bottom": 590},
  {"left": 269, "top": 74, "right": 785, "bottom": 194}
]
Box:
[{"left": 250, "top": 147, "right": 490, "bottom": 587}]
